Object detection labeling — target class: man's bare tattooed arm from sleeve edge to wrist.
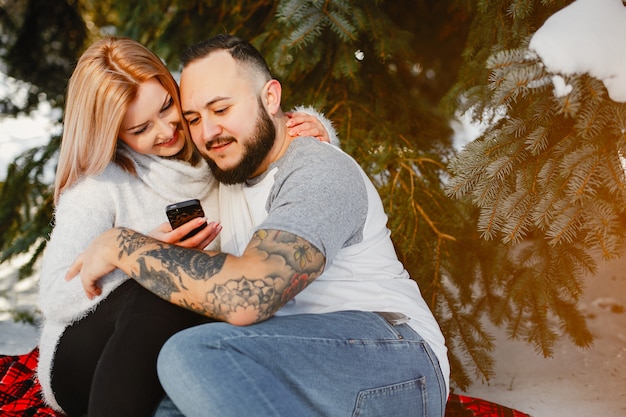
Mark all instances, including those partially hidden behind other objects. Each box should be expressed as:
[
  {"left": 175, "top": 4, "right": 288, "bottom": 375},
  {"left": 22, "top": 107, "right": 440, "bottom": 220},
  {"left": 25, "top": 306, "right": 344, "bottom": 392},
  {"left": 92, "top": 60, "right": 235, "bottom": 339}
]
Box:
[{"left": 86, "top": 229, "right": 325, "bottom": 325}]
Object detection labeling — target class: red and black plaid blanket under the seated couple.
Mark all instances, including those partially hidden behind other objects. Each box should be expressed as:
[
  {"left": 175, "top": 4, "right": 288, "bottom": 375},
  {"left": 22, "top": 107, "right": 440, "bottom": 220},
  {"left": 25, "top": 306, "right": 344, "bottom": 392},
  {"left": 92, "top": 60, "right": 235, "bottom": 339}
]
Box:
[{"left": 0, "top": 348, "right": 530, "bottom": 417}]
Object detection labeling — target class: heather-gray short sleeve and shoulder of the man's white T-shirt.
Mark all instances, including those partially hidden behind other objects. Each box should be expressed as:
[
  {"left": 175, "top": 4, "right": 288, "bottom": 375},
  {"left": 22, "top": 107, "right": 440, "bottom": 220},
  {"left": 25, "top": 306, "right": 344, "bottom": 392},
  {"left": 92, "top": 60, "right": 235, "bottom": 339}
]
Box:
[{"left": 247, "top": 138, "right": 367, "bottom": 264}]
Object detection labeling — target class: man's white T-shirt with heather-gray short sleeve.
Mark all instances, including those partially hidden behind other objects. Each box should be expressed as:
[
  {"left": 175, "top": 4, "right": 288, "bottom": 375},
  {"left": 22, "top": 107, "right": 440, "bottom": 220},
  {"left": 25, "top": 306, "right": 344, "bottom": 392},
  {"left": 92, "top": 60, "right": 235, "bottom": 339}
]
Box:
[{"left": 220, "top": 138, "right": 450, "bottom": 390}]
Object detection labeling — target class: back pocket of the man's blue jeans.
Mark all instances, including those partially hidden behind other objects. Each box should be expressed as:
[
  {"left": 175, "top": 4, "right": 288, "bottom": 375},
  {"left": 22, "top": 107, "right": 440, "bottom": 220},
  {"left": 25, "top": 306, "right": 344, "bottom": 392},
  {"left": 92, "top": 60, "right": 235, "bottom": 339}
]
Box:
[{"left": 352, "top": 377, "right": 427, "bottom": 417}]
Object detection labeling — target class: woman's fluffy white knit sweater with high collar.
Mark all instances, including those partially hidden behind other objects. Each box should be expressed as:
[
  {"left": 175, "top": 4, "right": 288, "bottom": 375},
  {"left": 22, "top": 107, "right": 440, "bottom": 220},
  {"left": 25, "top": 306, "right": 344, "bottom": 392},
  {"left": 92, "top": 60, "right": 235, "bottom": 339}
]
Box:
[{"left": 38, "top": 145, "right": 219, "bottom": 410}]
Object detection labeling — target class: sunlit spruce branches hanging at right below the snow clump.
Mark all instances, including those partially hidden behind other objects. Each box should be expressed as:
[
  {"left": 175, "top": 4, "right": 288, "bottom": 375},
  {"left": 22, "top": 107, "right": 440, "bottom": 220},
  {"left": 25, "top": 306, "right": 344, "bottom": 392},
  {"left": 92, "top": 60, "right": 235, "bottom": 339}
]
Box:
[{"left": 448, "top": 2, "right": 626, "bottom": 356}]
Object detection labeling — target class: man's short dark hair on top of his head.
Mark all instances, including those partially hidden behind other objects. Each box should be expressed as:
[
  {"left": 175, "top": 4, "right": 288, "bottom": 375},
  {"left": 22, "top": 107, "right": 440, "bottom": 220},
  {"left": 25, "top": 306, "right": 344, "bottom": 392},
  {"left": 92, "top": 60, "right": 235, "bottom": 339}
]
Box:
[{"left": 180, "top": 33, "right": 272, "bottom": 80}]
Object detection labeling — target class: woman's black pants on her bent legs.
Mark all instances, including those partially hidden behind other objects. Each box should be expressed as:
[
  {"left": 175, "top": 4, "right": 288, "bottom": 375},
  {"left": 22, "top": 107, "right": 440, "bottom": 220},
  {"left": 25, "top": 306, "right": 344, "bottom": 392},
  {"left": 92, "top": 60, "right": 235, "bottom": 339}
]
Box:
[{"left": 52, "top": 279, "right": 210, "bottom": 417}]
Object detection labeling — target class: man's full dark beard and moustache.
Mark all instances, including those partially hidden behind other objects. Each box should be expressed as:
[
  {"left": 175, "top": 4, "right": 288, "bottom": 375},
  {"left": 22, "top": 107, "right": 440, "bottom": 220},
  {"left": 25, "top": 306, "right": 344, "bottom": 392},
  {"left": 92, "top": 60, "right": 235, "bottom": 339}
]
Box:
[{"left": 205, "top": 102, "right": 276, "bottom": 184}]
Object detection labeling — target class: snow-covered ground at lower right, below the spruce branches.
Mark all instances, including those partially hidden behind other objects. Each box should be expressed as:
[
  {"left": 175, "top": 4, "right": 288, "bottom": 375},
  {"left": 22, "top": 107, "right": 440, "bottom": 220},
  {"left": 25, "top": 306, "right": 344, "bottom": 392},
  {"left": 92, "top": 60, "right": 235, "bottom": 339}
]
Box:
[{"left": 458, "top": 254, "right": 626, "bottom": 417}]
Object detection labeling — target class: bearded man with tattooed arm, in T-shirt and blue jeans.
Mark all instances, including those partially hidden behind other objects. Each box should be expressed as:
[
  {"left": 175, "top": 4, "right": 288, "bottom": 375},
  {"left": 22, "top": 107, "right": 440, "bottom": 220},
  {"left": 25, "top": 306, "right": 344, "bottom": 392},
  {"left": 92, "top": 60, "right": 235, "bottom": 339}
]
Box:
[{"left": 69, "top": 35, "right": 449, "bottom": 417}]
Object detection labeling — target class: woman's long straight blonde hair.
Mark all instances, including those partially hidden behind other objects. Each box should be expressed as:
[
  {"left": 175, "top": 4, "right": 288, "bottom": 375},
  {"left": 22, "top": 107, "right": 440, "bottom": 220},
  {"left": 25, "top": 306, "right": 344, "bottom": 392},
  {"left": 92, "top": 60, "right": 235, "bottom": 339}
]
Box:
[{"left": 54, "top": 37, "right": 200, "bottom": 204}]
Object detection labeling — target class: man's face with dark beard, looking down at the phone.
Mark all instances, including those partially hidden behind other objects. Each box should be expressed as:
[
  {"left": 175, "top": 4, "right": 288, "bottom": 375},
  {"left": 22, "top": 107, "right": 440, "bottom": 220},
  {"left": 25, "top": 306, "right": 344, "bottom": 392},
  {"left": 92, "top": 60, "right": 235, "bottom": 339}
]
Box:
[{"left": 180, "top": 51, "right": 276, "bottom": 184}]
